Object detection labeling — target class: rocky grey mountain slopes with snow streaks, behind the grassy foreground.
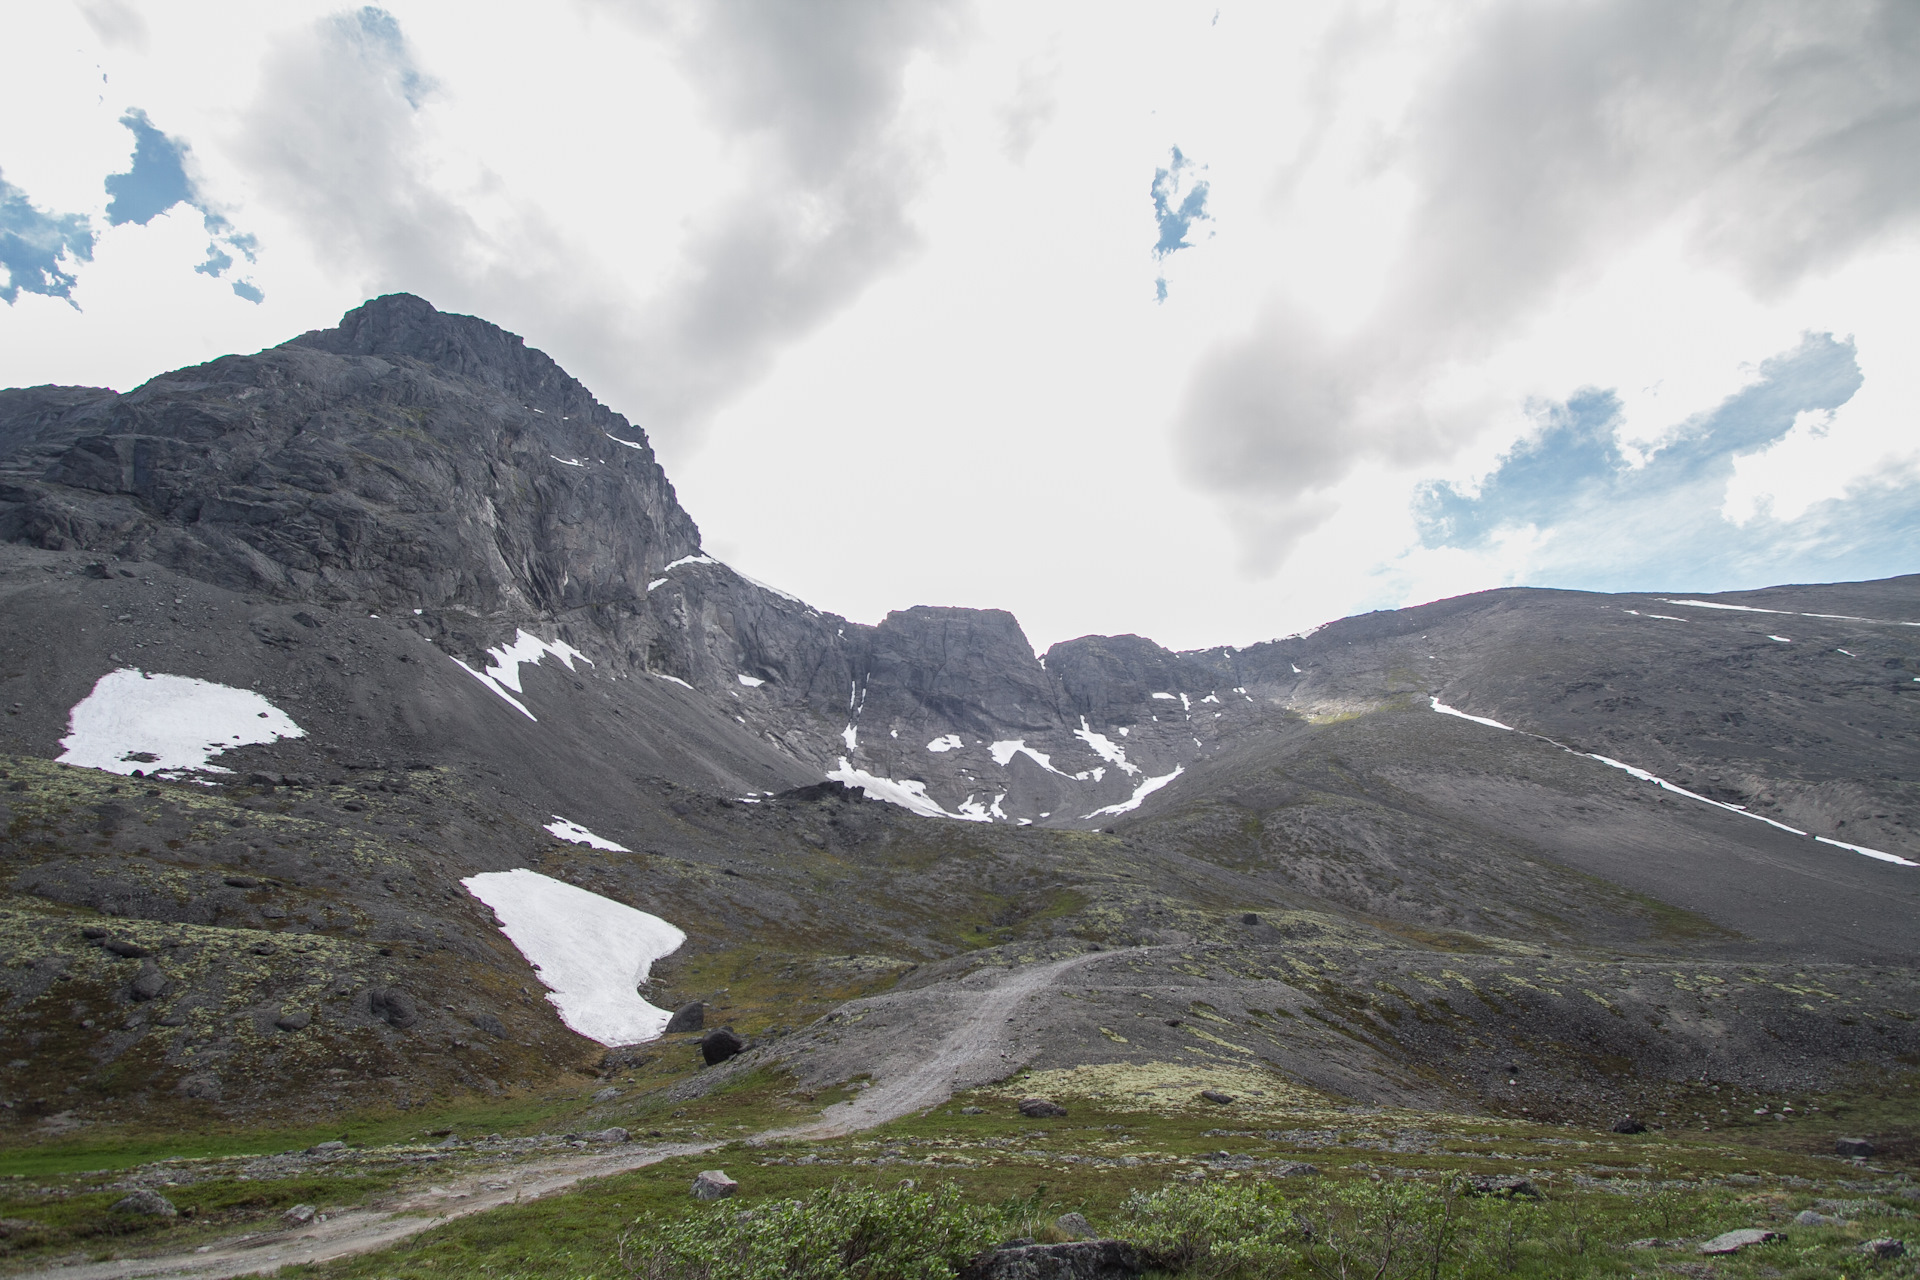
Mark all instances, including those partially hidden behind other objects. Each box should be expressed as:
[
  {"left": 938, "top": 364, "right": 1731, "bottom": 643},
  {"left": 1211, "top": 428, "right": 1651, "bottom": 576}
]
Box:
[{"left": 0, "top": 296, "right": 1920, "bottom": 1125}]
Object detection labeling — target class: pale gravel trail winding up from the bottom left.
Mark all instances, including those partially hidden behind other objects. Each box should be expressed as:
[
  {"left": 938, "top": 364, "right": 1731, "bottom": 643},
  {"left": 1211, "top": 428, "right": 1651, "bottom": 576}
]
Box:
[{"left": 21, "top": 948, "right": 1144, "bottom": 1280}]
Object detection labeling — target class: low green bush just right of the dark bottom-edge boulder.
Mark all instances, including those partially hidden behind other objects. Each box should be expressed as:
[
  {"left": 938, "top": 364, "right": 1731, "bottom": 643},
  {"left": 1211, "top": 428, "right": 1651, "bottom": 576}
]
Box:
[{"left": 1117, "top": 1182, "right": 1296, "bottom": 1280}]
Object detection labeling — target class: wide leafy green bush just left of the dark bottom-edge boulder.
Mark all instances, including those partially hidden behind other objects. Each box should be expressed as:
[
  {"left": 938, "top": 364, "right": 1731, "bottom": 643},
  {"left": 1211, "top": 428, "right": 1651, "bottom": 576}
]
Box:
[{"left": 622, "top": 1186, "right": 1002, "bottom": 1280}]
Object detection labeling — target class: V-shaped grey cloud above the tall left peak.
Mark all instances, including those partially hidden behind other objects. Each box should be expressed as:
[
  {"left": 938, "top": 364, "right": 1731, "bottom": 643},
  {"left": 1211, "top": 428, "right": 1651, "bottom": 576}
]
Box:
[{"left": 246, "top": 0, "right": 956, "bottom": 450}]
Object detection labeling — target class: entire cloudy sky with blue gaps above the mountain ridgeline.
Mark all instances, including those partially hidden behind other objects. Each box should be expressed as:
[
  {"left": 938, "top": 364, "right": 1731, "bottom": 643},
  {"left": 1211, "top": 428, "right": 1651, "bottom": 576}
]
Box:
[{"left": 0, "top": 0, "right": 1920, "bottom": 649}]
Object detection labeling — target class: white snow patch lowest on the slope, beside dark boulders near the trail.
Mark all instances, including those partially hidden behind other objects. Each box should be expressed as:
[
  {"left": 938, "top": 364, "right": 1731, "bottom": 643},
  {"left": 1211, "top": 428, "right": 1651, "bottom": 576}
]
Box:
[{"left": 461, "top": 867, "right": 687, "bottom": 1044}]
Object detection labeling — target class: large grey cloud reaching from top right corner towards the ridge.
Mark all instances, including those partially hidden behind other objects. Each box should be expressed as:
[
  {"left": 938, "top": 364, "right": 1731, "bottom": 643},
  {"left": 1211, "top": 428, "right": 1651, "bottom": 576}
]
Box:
[{"left": 1181, "top": 0, "right": 1920, "bottom": 564}]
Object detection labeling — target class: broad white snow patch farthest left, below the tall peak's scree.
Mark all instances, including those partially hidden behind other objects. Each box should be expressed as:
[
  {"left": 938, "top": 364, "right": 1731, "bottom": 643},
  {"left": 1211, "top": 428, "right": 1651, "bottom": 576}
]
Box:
[{"left": 60, "top": 666, "right": 307, "bottom": 773}]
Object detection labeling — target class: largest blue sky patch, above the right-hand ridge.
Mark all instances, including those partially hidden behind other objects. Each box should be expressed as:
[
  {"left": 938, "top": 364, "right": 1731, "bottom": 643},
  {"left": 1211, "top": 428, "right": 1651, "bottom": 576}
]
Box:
[{"left": 1415, "top": 334, "right": 1920, "bottom": 591}]
